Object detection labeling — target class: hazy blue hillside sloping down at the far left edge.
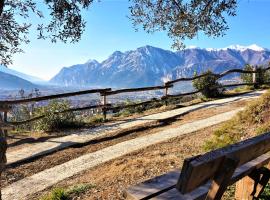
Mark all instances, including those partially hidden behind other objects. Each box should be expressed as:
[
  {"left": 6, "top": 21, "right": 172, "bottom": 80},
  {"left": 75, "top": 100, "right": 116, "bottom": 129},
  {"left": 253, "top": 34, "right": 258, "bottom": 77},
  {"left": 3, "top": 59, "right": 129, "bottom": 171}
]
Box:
[{"left": 0, "top": 72, "right": 37, "bottom": 90}]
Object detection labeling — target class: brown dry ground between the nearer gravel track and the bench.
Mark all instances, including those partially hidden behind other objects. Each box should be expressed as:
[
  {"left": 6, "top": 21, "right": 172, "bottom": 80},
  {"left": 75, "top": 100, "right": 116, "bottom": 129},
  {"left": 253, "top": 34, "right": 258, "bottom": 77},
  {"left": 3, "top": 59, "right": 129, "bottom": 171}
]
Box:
[{"left": 29, "top": 125, "right": 220, "bottom": 200}]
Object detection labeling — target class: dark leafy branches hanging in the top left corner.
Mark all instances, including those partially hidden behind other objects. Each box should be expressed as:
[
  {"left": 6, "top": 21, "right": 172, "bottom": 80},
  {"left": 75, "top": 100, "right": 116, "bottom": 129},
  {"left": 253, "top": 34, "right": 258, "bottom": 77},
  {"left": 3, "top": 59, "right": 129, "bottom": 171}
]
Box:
[{"left": 0, "top": 0, "right": 93, "bottom": 65}]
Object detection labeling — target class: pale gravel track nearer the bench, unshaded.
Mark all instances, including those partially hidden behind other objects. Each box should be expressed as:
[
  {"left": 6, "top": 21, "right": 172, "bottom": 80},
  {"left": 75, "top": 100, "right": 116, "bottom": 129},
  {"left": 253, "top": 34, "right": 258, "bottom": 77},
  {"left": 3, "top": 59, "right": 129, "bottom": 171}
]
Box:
[{"left": 2, "top": 108, "right": 243, "bottom": 200}]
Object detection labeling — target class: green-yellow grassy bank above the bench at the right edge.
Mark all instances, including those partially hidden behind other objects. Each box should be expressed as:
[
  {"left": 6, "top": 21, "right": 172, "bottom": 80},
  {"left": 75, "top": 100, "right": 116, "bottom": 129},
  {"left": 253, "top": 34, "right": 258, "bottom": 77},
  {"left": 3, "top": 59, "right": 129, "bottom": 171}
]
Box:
[{"left": 204, "top": 91, "right": 270, "bottom": 151}]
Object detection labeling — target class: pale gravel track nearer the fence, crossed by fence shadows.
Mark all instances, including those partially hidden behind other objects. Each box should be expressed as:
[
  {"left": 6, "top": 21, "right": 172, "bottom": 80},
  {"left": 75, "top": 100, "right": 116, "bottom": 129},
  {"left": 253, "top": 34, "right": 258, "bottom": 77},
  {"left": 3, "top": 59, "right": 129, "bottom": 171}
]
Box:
[{"left": 7, "top": 91, "right": 264, "bottom": 164}]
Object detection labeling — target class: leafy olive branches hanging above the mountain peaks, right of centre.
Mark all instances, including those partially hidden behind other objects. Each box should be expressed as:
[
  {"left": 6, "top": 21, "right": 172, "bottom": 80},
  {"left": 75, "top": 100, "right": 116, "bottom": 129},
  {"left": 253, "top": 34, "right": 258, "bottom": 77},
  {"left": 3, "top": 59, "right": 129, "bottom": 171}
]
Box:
[{"left": 130, "top": 0, "right": 237, "bottom": 48}]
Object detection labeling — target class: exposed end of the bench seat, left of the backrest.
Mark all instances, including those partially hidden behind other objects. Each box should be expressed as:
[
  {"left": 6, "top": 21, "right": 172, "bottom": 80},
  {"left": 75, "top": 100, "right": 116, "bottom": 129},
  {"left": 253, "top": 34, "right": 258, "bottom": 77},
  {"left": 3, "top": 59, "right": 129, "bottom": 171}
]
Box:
[{"left": 125, "top": 170, "right": 180, "bottom": 200}]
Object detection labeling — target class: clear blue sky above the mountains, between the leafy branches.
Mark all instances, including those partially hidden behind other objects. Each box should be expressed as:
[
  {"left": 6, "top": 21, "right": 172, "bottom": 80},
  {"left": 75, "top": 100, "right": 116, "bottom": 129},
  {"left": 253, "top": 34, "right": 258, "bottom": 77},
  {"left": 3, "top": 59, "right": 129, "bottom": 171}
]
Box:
[{"left": 10, "top": 0, "right": 270, "bottom": 80}]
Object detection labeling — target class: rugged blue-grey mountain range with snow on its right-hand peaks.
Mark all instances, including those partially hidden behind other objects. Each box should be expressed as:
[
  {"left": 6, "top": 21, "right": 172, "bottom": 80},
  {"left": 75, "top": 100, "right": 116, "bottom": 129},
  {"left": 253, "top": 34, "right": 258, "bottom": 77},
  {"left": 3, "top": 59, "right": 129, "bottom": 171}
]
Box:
[{"left": 50, "top": 45, "right": 270, "bottom": 87}]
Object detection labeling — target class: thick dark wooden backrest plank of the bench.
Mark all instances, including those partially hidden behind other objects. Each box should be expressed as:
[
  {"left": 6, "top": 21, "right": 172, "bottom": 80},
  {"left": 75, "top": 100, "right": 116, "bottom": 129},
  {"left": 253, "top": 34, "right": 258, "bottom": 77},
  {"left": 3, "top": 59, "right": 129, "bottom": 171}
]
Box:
[{"left": 176, "top": 133, "right": 270, "bottom": 194}]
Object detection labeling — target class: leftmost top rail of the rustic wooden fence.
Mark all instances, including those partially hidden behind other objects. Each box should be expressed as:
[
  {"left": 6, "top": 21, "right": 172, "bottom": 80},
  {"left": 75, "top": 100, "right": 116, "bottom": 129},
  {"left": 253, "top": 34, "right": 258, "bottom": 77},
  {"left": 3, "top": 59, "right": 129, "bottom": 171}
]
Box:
[{"left": 0, "top": 88, "right": 111, "bottom": 105}]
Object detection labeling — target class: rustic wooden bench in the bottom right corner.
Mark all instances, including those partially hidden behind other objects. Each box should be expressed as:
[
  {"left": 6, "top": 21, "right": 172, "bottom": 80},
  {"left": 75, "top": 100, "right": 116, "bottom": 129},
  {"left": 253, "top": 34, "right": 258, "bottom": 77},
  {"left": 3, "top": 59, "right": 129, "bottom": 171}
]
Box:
[{"left": 125, "top": 133, "right": 270, "bottom": 200}]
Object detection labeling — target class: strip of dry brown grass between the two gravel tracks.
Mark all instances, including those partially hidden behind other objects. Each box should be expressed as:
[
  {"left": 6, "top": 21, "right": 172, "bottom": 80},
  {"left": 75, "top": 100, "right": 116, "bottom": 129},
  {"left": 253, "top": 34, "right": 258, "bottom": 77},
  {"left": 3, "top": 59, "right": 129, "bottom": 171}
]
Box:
[{"left": 2, "top": 98, "right": 247, "bottom": 189}]
